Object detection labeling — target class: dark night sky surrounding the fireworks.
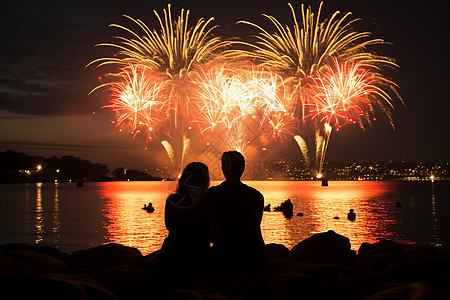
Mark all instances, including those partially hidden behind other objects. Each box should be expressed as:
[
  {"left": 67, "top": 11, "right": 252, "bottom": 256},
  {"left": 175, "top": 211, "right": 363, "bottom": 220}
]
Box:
[{"left": 0, "top": 0, "right": 450, "bottom": 169}]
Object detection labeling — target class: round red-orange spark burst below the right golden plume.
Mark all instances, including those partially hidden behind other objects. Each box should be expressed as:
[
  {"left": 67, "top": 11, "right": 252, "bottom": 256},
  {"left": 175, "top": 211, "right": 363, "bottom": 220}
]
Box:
[{"left": 305, "top": 58, "right": 392, "bottom": 128}]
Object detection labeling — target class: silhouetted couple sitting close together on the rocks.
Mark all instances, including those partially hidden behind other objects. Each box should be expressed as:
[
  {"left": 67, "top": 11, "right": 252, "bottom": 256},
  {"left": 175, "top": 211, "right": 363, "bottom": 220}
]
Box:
[{"left": 159, "top": 151, "right": 264, "bottom": 264}]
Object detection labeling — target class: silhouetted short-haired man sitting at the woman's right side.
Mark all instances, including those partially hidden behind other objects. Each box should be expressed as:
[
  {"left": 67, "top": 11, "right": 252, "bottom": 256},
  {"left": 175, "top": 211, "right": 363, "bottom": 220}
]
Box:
[{"left": 207, "top": 151, "right": 264, "bottom": 260}]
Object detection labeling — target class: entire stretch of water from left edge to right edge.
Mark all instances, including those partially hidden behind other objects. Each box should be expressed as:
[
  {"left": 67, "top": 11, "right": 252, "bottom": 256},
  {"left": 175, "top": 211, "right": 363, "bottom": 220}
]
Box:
[{"left": 0, "top": 181, "right": 450, "bottom": 254}]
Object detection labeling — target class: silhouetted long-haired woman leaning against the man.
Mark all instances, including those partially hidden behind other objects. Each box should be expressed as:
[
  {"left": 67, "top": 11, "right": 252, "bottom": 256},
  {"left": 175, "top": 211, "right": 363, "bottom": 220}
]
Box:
[{"left": 158, "top": 162, "right": 210, "bottom": 265}]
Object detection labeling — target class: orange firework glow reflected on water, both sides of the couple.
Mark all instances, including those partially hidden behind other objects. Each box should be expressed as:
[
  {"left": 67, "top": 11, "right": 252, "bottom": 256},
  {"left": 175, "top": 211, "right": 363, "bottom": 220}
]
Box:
[{"left": 100, "top": 181, "right": 407, "bottom": 254}]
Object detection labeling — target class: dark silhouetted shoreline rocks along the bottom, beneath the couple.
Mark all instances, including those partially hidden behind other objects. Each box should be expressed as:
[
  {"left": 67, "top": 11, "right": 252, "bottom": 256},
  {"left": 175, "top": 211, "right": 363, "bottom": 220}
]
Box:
[{"left": 0, "top": 231, "right": 450, "bottom": 300}]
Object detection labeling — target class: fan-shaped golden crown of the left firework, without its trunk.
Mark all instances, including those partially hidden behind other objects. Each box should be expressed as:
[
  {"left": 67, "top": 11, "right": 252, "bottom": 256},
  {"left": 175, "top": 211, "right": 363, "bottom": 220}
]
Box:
[{"left": 91, "top": 4, "right": 228, "bottom": 80}]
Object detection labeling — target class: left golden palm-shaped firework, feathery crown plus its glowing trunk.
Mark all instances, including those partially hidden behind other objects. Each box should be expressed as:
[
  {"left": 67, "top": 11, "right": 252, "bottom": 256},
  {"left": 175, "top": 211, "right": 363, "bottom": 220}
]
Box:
[{"left": 88, "top": 4, "right": 229, "bottom": 128}]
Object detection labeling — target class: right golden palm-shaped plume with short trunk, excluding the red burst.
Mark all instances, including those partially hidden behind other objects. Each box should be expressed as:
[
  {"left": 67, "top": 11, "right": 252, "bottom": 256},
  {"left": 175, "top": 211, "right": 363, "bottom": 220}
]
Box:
[{"left": 228, "top": 2, "right": 397, "bottom": 118}]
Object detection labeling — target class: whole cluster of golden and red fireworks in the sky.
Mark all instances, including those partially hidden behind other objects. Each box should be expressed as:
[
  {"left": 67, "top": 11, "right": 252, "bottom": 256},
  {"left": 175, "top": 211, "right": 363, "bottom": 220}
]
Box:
[{"left": 91, "top": 3, "right": 401, "bottom": 174}]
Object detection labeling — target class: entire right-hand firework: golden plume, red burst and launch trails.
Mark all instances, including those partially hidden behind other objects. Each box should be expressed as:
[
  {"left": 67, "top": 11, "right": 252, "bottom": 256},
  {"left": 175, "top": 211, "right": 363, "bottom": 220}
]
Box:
[{"left": 229, "top": 3, "right": 401, "bottom": 173}]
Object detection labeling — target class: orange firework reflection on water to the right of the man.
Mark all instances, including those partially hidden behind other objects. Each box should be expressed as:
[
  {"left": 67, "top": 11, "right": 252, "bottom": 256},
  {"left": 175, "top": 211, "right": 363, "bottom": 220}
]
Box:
[{"left": 248, "top": 181, "right": 412, "bottom": 250}]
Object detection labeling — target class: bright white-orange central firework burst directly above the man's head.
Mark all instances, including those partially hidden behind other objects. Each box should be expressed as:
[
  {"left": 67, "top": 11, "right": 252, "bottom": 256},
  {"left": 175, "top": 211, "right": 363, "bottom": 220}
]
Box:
[{"left": 196, "top": 64, "right": 291, "bottom": 152}]
